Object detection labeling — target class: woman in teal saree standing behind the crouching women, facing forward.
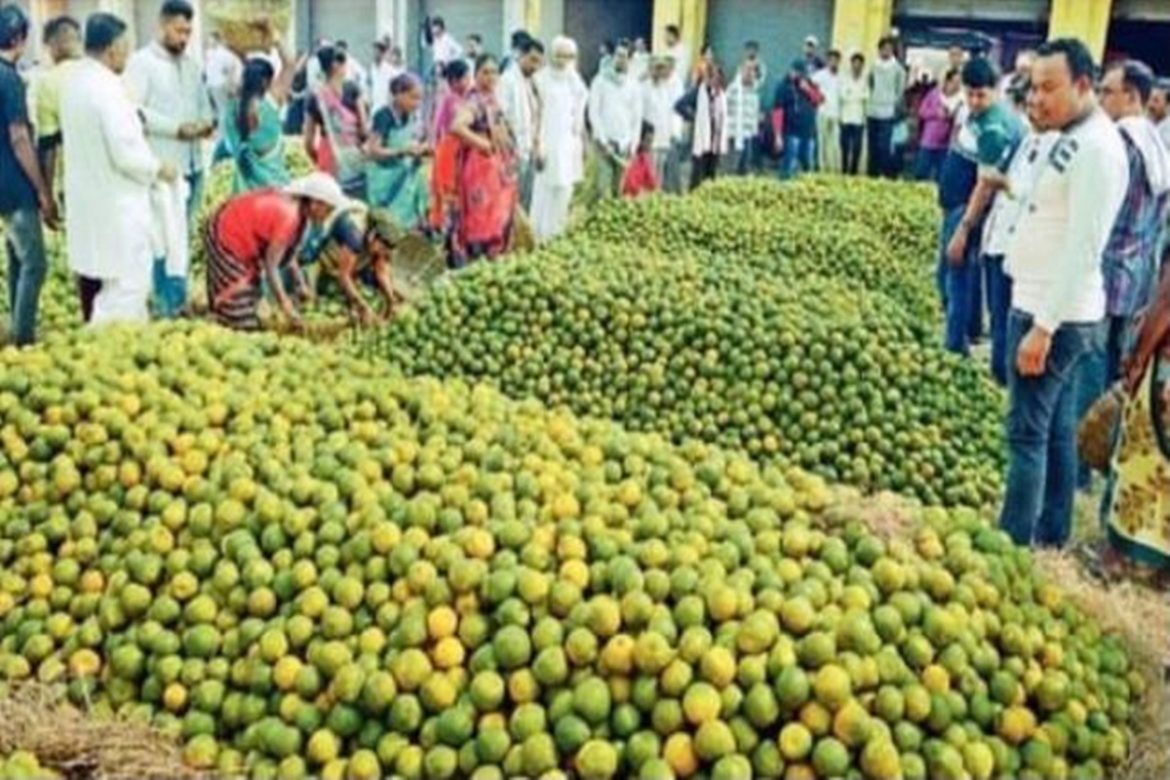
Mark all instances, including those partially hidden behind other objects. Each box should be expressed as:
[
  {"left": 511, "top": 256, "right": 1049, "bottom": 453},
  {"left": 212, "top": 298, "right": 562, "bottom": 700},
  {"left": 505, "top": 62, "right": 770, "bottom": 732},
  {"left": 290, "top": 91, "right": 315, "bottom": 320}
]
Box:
[{"left": 366, "top": 74, "right": 432, "bottom": 230}]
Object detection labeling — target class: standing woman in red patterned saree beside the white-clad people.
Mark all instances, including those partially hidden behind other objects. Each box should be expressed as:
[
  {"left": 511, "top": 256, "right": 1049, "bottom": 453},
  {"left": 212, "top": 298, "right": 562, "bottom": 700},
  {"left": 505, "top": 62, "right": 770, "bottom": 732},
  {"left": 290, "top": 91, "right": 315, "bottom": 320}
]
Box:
[{"left": 450, "top": 54, "right": 519, "bottom": 267}]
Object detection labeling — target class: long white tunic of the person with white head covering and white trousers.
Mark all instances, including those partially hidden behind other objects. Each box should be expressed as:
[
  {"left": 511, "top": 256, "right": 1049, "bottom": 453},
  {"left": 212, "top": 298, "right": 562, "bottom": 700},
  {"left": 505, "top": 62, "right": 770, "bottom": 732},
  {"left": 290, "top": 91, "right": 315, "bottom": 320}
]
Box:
[{"left": 532, "top": 67, "right": 589, "bottom": 187}]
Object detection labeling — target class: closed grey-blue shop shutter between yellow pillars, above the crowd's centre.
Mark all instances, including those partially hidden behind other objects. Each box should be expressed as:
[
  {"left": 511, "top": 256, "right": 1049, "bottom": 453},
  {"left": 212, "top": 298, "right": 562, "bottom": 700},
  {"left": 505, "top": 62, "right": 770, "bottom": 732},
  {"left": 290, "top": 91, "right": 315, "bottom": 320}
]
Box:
[{"left": 707, "top": 0, "right": 833, "bottom": 105}]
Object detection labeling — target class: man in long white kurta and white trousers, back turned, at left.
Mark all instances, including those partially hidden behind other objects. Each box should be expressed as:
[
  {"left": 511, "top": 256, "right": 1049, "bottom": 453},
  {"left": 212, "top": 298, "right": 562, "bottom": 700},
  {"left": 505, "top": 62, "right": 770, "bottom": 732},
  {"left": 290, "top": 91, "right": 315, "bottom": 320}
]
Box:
[{"left": 61, "top": 13, "right": 178, "bottom": 325}]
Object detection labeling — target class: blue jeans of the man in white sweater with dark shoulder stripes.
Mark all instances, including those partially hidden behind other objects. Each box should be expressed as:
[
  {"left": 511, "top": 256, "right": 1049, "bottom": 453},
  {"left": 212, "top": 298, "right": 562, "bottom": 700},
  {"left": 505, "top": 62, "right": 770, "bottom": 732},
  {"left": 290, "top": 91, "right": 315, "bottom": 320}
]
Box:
[{"left": 999, "top": 309, "right": 1104, "bottom": 547}]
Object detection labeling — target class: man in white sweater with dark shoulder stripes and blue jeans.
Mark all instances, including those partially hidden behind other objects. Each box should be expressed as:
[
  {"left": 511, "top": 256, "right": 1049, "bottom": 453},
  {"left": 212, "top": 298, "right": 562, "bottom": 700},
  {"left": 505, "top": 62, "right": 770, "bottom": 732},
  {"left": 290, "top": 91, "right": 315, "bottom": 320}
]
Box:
[{"left": 999, "top": 39, "right": 1129, "bottom": 547}]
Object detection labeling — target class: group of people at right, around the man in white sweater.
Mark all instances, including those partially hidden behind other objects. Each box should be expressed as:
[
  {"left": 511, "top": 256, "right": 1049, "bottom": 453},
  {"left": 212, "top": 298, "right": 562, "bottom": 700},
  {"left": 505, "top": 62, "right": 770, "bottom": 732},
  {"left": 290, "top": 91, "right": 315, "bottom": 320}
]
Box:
[{"left": 916, "top": 39, "right": 1170, "bottom": 582}]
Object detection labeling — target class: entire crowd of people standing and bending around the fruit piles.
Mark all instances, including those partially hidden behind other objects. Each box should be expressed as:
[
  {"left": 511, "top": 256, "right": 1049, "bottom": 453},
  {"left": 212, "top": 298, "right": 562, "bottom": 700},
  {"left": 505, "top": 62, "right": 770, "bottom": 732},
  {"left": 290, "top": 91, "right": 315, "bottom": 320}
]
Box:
[{"left": 0, "top": 0, "right": 1170, "bottom": 577}]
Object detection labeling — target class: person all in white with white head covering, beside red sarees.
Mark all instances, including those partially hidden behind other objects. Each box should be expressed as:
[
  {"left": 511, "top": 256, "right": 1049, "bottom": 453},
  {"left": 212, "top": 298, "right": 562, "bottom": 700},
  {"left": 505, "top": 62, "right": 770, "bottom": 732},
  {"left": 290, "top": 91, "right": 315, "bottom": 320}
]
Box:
[{"left": 532, "top": 37, "right": 589, "bottom": 242}]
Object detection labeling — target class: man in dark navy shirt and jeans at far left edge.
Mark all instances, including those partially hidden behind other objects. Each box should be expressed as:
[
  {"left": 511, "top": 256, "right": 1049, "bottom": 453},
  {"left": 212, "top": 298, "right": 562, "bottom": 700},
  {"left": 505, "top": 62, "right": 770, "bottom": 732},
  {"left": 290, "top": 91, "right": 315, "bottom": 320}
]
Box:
[{"left": 0, "top": 4, "right": 57, "bottom": 346}]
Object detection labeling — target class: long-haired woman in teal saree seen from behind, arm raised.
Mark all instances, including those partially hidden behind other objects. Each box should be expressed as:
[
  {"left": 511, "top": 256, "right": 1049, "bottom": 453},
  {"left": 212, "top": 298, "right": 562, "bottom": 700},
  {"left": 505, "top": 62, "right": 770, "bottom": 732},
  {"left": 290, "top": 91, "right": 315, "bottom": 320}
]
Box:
[{"left": 225, "top": 50, "right": 298, "bottom": 193}]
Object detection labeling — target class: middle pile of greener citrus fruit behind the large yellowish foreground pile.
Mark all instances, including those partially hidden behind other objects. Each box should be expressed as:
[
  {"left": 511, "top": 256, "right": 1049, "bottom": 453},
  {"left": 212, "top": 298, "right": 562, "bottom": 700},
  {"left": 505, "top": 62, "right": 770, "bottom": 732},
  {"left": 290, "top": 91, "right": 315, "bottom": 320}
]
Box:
[{"left": 366, "top": 246, "right": 1003, "bottom": 506}]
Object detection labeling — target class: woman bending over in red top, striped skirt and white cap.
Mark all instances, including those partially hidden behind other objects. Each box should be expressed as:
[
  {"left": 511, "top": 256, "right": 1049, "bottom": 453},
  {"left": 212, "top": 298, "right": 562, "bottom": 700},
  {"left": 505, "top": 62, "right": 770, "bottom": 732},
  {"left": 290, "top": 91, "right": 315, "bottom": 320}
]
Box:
[{"left": 204, "top": 173, "right": 351, "bottom": 330}]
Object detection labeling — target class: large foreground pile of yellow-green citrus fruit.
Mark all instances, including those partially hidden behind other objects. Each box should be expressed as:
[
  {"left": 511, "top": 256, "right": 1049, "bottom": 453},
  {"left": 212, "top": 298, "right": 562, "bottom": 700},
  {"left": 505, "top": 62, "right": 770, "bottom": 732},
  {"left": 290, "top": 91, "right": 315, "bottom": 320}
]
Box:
[{"left": 0, "top": 322, "right": 1141, "bottom": 780}]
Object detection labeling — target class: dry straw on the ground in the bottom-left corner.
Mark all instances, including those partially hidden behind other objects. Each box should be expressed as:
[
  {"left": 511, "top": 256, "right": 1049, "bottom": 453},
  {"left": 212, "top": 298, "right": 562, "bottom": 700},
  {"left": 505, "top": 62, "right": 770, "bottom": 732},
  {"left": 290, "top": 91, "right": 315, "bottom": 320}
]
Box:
[{"left": 0, "top": 683, "right": 195, "bottom": 780}]
